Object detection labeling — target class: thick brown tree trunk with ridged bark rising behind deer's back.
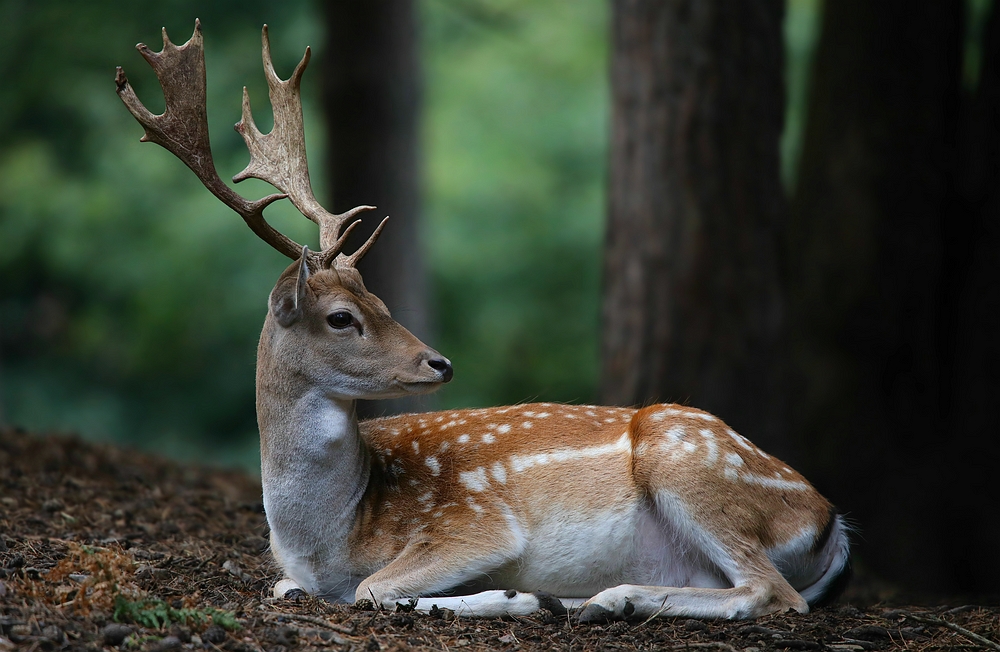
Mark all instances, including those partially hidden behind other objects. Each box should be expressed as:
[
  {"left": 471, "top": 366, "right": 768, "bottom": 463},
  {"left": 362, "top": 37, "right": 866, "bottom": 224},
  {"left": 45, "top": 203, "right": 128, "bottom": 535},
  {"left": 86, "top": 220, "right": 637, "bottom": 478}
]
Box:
[{"left": 602, "top": 0, "right": 786, "bottom": 454}]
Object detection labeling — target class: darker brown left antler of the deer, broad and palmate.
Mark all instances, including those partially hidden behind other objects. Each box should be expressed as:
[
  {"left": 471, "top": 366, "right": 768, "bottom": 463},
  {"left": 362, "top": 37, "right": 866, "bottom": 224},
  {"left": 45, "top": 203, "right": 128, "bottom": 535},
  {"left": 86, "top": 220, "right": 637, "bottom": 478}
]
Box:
[{"left": 115, "top": 19, "right": 302, "bottom": 260}]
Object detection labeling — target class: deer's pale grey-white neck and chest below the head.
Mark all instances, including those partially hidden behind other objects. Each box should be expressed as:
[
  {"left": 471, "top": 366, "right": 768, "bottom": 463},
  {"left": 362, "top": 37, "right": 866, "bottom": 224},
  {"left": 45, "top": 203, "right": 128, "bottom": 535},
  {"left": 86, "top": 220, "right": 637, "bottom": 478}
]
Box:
[{"left": 257, "top": 348, "right": 371, "bottom": 599}]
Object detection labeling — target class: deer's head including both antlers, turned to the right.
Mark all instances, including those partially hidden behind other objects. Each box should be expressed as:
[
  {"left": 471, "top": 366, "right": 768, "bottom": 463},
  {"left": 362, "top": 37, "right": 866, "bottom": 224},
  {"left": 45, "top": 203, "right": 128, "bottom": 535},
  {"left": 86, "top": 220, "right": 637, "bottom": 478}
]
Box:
[{"left": 116, "top": 20, "right": 452, "bottom": 400}]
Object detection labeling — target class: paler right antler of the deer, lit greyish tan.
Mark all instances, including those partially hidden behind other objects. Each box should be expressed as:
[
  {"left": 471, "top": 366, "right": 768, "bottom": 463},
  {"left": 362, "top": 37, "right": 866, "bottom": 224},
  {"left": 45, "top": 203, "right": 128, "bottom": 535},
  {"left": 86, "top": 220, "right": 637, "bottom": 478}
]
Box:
[{"left": 233, "top": 25, "right": 372, "bottom": 260}]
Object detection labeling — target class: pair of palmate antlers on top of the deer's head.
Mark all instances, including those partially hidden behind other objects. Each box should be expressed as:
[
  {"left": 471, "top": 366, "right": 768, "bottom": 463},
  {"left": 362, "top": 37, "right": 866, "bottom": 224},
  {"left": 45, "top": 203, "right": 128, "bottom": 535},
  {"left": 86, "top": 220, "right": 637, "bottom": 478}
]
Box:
[{"left": 115, "top": 20, "right": 388, "bottom": 269}]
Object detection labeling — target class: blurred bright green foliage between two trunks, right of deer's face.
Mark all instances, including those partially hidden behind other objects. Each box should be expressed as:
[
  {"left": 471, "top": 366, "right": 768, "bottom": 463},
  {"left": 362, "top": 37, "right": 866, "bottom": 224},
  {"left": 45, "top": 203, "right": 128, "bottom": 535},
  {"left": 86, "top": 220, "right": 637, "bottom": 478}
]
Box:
[{"left": 423, "top": 0, "right": 608, "bottom": 406}]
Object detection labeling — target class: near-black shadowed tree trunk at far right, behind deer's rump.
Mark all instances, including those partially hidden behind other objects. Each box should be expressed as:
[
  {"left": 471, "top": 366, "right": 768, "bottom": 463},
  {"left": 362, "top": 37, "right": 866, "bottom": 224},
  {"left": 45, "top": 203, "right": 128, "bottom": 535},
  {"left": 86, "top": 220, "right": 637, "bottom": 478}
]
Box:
[{"left": 788, "top": 0, "right": 1000, "bottom": 592}]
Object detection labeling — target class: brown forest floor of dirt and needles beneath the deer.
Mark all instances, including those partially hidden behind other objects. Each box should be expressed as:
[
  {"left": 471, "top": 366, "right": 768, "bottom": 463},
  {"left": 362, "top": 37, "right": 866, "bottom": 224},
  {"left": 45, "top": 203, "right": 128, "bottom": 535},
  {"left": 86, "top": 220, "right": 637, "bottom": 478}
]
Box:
[{"left": 0, "top": 429, "right": 1000, "bottom": 652}]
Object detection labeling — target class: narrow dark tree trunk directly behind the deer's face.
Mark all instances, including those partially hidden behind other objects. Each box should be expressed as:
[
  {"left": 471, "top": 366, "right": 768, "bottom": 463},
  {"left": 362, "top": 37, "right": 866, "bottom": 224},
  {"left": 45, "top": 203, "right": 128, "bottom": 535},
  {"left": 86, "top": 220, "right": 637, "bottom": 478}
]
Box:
[{"left": 323, "top": 0, "right": 433, "bottom": 415}]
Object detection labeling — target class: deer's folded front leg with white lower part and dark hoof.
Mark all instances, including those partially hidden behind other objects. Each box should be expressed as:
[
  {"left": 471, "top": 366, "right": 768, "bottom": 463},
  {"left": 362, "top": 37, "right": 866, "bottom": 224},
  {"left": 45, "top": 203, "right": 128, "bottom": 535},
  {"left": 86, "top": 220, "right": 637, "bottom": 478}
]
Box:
[{"left": 355, "top": 539, "right": 566, "bottom": 618}]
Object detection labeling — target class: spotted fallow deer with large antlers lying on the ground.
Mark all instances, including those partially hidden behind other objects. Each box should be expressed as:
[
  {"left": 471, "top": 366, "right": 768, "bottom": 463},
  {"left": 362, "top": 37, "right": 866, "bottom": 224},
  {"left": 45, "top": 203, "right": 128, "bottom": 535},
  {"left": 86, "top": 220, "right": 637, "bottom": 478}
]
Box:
[{"left": 116, "top": 20, "right": 850, "bottom": 622}]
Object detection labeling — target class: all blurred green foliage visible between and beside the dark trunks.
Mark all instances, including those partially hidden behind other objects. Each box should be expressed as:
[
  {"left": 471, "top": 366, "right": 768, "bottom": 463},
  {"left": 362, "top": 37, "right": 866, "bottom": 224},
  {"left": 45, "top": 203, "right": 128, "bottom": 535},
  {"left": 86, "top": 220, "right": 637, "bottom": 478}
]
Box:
[{"left": 0, "top": 0, "right": 820, "bottom": 469}]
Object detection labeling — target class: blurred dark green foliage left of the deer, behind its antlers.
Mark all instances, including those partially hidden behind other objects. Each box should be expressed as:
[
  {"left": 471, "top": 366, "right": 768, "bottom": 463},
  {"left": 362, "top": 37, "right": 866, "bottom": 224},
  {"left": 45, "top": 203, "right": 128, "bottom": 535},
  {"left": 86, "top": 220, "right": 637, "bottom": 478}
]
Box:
[{"left": 0, "top": 0, "right": 321, "bottom": 465}]
